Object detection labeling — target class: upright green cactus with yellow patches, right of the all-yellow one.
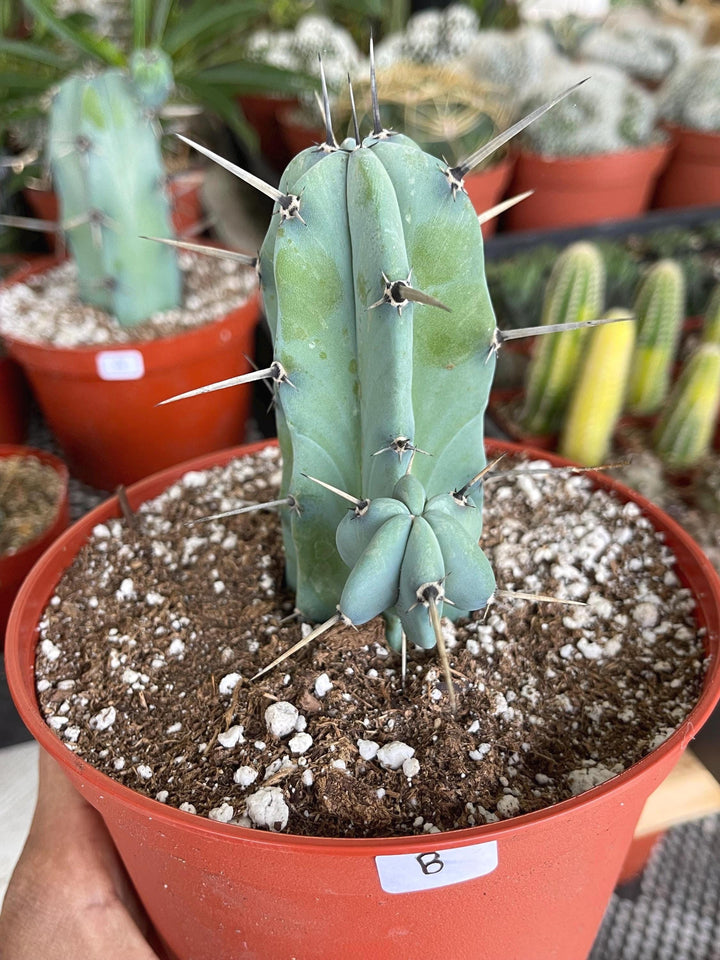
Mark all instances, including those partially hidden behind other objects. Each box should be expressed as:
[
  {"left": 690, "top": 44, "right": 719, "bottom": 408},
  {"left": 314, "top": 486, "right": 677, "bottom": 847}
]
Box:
[{"left": 627, "top": 260, "right": 685, "bottom": 414}]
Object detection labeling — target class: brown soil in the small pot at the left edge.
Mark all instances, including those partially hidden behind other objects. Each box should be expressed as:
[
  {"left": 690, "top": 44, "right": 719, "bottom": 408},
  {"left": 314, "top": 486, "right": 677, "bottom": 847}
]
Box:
[{"left": 0, "top": 456, "right": 63, "bottom": 557}]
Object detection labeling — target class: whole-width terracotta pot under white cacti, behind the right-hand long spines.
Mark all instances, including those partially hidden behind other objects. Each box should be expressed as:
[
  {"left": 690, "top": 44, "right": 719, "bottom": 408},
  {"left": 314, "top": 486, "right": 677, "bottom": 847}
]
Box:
[{"left": 505, "top": 144, "right": 670, "bottom": 230}]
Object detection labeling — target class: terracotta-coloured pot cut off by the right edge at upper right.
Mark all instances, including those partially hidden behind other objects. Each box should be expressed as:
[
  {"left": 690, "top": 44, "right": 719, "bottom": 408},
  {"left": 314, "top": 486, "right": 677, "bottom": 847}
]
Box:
[{"left": 653, "top": 126, "right": 720, "bottom": 207}]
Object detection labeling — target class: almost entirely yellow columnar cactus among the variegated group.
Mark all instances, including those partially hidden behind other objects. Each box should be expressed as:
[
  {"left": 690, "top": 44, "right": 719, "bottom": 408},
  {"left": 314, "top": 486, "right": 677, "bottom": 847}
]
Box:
[{"left": 560, "top": 310, "right": 635, "bottom": 466}]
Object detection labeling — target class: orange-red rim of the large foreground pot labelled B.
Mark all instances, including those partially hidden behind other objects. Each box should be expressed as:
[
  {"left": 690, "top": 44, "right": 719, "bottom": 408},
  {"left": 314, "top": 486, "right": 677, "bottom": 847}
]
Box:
[{"left": 5, "top": 440, "right": 720, "bottom": 857}]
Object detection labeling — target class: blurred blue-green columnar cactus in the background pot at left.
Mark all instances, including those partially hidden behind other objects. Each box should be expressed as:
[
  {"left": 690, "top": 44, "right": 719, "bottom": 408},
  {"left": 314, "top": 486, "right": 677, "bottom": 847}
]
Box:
[{"left": 48, "top": 51, "right": 182, "bottom": 326}]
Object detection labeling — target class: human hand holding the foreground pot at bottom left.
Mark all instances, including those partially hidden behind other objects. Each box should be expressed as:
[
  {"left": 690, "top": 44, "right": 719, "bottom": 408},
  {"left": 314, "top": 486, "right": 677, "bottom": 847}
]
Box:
[{"left": 0, "top": 750, "right": 159, "bottom": 960}]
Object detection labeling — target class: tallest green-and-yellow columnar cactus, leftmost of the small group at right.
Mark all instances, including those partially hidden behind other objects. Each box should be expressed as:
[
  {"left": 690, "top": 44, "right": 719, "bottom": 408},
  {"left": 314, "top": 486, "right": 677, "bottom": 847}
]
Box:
[{"left": 521, "top": 243, "right": 605, "bottom": 435}]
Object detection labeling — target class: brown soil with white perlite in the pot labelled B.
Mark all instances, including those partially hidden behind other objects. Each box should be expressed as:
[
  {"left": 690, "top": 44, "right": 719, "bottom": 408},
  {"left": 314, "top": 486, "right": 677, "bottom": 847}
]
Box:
[{"left": 36, "top": 449, "right": 704, "bottom": 837}]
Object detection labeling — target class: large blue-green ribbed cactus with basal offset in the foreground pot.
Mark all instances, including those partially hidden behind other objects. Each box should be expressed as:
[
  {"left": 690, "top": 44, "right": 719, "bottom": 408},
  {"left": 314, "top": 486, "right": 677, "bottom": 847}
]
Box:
[{"left": 260, "top": 133, "right": 495, "bottom": 647}]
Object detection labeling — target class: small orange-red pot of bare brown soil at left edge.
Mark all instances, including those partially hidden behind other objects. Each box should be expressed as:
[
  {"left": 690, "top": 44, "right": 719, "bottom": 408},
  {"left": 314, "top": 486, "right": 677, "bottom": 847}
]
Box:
[{"left": 0, "top": 444, "right": 70, "bottom": 650}]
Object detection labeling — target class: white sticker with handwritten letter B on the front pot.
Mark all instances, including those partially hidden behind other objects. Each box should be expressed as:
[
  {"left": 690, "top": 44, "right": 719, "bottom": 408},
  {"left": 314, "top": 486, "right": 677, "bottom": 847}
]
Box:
[{"left": 375, "top": 840, "right": 498, "bottom": 893}]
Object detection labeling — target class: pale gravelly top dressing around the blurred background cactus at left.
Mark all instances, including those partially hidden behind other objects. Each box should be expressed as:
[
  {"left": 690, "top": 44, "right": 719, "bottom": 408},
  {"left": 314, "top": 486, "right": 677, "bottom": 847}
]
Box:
[{"left": 0, "top": 251, "right": 257, "bottom": 347}]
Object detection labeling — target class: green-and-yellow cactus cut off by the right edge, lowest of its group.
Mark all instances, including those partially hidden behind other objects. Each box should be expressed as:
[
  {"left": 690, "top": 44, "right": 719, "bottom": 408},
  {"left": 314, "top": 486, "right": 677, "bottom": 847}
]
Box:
[{"left": 653, "top": 343, "right": 720, "bottom": 470}]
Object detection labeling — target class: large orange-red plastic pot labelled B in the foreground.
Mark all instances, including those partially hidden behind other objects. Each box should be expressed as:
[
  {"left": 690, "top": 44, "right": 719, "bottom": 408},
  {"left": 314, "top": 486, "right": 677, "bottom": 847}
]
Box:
[{"left": 6, "top": 443, "right": 720, "bottom": 960}]
